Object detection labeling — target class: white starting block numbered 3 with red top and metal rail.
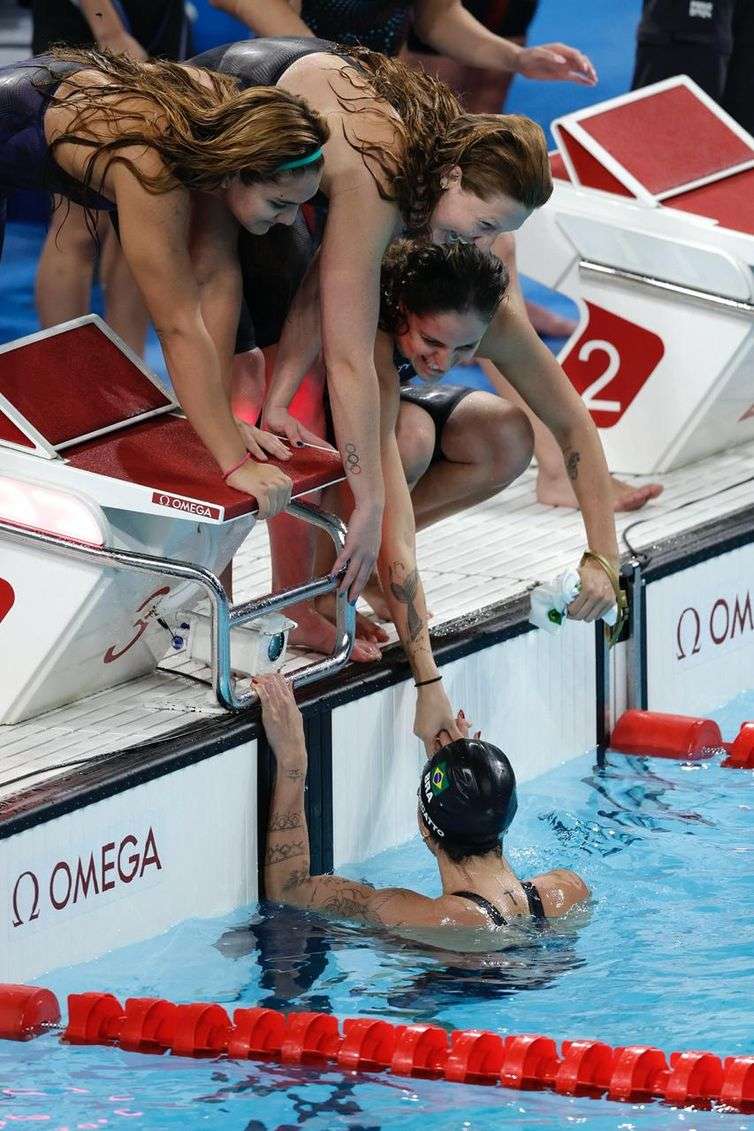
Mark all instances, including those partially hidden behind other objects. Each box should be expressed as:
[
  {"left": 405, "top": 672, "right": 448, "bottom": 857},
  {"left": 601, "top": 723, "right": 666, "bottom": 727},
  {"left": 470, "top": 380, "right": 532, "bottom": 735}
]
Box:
[{"left": 0, "top": 316, "right": 355, "bottom": 724}]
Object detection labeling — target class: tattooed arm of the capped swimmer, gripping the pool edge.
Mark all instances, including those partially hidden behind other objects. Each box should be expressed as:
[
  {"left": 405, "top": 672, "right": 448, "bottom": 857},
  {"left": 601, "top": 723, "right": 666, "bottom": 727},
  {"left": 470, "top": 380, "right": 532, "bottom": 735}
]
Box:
[{"left": 260, "top": 675, "right": 462, "bottom": 930}]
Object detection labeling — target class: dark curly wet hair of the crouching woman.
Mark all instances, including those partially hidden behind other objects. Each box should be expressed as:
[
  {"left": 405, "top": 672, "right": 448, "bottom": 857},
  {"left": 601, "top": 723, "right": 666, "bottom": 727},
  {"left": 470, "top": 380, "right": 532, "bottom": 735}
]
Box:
[{"left": 380, "top": 240, "right": 509, "bottom": 334}]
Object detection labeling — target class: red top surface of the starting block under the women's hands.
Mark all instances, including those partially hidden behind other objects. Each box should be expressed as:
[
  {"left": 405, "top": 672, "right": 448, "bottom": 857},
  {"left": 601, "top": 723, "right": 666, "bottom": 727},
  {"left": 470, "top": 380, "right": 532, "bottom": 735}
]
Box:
[{"left": 0, "top": 316, "right": 344, "bottom": 520}]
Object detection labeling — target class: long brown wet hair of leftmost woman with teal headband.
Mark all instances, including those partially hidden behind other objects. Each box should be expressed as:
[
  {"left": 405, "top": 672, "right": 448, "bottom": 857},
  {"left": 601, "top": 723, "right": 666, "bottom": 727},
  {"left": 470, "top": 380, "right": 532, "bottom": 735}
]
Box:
[{"left": 50, "top": 49, "right": 329, "bottom": 193}]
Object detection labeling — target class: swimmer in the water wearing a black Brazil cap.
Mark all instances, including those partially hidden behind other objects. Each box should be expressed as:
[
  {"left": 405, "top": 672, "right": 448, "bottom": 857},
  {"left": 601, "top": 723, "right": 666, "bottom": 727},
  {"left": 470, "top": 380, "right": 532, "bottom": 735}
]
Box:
[{"left": 252, "top": 675, "right": 589, "bottom": 950}]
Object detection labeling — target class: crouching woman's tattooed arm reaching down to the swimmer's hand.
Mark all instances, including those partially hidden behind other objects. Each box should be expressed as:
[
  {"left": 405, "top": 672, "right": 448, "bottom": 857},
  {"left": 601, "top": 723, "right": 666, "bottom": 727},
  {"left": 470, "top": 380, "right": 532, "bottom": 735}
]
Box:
[{"left": 374, "top": 333, "right": 462, "bottom": 754}]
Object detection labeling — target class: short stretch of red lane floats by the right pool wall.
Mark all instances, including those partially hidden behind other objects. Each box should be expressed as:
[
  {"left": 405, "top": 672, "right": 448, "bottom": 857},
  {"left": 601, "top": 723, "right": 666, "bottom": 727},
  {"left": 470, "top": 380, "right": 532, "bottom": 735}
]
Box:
[{"left": 610, "top": 710, "right": 754, "bottom": 769}]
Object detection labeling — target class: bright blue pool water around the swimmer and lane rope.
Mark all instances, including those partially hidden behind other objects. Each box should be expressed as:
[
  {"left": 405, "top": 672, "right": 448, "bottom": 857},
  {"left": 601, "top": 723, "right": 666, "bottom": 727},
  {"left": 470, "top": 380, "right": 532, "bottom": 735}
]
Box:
[{"left": 0, "top": 694, "right": 754, "bottom": 1131}]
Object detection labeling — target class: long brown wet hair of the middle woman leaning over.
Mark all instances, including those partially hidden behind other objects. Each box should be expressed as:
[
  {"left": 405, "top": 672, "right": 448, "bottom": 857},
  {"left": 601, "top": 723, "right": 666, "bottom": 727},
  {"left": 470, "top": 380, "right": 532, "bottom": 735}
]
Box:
[{"left": 338, "top": 48, "right": 553, "bottom": 233}]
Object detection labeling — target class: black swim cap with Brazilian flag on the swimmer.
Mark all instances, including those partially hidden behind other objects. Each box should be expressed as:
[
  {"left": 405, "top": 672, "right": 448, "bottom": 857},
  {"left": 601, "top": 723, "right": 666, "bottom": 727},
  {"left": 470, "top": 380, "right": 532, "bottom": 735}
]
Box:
[{"left": 418, "top": 739, "right": 518, "bottom": 852}]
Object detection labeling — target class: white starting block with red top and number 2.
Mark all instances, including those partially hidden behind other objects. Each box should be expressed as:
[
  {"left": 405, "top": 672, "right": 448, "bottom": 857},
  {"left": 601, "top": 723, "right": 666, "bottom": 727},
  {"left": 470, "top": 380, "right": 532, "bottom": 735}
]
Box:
[{"left": 517, "top": 76, "right": 754, "bottom": 474}]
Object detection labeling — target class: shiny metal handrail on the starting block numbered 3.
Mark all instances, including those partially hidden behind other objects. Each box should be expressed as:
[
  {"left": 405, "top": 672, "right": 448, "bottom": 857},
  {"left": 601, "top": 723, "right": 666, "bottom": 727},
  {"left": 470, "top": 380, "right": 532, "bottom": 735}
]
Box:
[{"left": 0, "top": 502, "right": 356, "bottom": 710}]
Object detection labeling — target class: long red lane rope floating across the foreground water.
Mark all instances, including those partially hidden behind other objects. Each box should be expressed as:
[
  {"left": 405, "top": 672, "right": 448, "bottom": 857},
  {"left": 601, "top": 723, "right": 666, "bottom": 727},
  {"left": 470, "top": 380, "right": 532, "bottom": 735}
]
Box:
[{"left": 0, "top": 985, "right": 754, "bottom": 1112}]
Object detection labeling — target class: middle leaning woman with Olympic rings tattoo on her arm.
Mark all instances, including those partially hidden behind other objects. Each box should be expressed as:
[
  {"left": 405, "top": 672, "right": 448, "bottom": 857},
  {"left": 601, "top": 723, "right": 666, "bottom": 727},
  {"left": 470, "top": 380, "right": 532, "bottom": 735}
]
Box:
[{"left": 194, "top": 40, "right": 618, "bottom": 650}]
